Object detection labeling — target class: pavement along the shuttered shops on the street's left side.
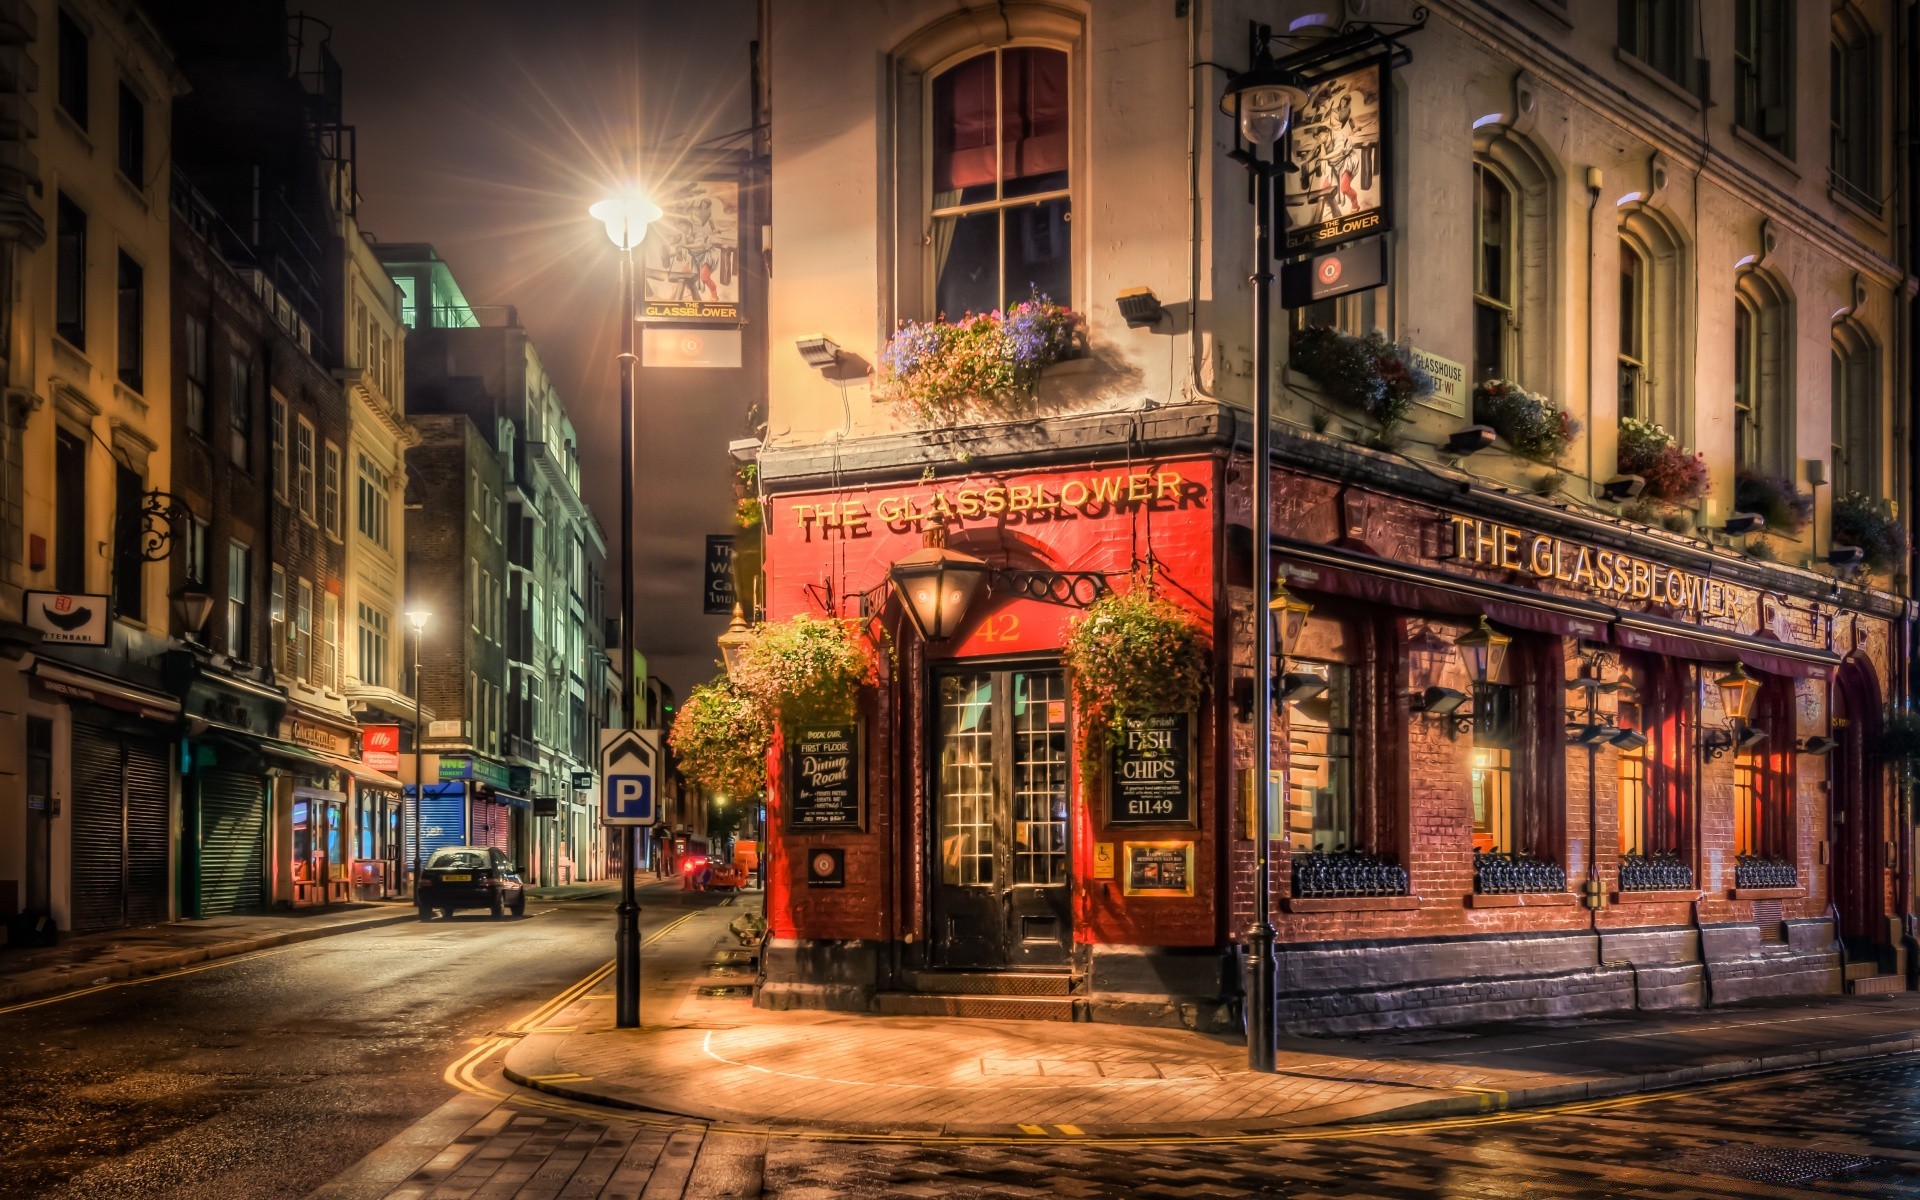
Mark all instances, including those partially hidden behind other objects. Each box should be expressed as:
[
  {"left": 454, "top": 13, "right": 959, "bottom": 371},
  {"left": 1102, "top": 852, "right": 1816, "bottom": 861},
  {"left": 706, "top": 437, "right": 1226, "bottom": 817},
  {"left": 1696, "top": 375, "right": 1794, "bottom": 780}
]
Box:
[{"left": 0, "top": 881, "right": 616, "bottom": 1008}]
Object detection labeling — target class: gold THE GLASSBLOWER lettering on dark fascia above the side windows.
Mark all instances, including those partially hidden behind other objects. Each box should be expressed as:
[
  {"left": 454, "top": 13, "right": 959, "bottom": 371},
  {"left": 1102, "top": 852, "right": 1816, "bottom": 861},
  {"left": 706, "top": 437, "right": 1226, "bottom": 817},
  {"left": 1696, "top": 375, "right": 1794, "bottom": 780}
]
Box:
[{"left": 1448, "top": 515, "right": 1734, "bottom": 616}]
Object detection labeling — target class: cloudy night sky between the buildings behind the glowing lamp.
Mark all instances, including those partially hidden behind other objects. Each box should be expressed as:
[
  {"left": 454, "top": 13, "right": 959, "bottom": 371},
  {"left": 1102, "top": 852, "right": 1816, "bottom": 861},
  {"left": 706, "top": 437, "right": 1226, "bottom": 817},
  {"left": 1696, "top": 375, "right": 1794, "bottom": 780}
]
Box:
[{"left": 305, "top": 0, "right": 756, "bottom": 695}]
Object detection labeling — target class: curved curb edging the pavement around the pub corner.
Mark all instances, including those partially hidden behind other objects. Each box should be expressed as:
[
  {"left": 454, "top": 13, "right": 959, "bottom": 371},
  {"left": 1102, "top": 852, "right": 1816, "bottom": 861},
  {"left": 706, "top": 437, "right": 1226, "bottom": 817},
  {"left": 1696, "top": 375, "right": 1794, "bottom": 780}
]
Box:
[{"left": 501, "top": 1031, "right": 1920, "bottom": 1142}]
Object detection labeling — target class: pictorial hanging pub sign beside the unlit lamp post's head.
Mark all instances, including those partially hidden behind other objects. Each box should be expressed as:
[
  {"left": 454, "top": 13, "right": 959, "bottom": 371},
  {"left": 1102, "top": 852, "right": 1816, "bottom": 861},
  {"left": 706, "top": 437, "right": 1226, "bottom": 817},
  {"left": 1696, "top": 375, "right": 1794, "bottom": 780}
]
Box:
[{"left": 1281, "top": 54, "right": 1392, "bottom": 255}]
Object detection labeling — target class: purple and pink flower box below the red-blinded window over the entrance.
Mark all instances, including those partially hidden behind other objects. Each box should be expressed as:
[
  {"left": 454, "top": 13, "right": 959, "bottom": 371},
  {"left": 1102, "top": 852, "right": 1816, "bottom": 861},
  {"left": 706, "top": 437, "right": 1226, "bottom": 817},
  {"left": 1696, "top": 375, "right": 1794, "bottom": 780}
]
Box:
[{"left": 877, "top": 292, "right": 1085, "bottom": 428}]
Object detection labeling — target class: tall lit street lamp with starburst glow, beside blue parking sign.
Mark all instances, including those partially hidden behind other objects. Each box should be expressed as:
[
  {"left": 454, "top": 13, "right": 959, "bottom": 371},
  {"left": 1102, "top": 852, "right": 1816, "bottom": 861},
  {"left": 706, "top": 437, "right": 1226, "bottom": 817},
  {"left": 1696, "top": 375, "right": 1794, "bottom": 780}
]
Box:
[{"left": 588, "top": 188, "right": 660, "bottom": 1029}]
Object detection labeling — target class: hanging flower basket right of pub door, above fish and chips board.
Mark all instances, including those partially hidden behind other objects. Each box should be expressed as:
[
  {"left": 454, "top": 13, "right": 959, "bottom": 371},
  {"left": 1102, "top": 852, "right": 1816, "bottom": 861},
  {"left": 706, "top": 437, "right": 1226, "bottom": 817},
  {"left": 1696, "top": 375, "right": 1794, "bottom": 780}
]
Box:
[{"left": 1062, "top": 580, "right": 1208, "bottom": 778}]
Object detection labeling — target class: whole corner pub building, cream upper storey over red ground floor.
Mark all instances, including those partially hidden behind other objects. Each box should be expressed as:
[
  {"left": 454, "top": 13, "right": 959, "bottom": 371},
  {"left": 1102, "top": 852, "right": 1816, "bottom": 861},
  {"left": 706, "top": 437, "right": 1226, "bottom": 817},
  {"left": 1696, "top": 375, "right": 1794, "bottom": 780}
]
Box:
[{"left": 756, "top": 0, "right": 1914, "bottom": 1033}]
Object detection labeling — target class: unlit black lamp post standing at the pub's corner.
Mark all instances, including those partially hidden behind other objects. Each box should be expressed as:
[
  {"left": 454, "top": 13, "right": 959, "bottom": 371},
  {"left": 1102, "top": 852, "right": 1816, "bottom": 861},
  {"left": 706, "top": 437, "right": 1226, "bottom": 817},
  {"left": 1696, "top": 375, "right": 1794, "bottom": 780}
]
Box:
[{"left": 1219, "top": 25, "right": 1306, "bottom": 1073}]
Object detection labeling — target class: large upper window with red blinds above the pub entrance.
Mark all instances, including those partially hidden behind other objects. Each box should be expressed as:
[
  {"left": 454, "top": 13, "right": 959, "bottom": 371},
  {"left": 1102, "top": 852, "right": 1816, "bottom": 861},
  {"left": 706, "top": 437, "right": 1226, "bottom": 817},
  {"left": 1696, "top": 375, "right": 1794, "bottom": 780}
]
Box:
[{"left": 929, "top": 46, "right": 1073, "bottom": 319}]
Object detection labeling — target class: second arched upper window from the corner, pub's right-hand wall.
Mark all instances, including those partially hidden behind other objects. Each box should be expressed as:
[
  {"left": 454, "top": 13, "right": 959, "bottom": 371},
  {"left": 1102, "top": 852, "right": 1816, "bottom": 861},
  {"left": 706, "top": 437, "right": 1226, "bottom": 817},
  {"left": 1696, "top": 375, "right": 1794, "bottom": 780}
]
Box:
[{"left": 1619, "top": 207, "right": 1692, "bottom": 442}]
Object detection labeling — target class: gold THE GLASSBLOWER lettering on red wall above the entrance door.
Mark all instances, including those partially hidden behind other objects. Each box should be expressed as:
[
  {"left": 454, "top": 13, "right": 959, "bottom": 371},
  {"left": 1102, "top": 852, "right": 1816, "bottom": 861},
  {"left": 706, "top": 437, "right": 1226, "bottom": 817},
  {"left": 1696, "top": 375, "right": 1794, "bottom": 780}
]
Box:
[{"left": 787, "top": 470, "right": 1206, "bottom": 538}]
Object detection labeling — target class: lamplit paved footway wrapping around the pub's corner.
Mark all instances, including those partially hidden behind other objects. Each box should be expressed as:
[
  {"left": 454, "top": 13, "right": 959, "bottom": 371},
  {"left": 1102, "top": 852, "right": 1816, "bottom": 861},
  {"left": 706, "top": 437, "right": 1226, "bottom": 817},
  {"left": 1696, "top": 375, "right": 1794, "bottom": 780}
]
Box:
[{"left": 501, "top": 899, "right": 1920, "bottom": 1139}]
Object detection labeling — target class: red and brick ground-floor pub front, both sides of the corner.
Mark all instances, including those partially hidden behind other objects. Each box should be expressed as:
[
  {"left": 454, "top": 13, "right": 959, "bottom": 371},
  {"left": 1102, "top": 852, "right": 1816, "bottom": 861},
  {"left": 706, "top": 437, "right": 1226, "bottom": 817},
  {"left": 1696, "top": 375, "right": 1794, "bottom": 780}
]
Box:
[{"left": 758, "top": 430, "right": 1910, "bottom": 1031}]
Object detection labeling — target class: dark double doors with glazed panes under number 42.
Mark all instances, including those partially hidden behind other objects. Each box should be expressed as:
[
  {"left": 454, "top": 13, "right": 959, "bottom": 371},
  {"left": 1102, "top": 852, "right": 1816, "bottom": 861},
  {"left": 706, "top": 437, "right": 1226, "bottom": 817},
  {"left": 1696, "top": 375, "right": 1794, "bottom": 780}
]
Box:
[{"left": 931, "top": 666, "right": 1073, "bottom": 970}]
